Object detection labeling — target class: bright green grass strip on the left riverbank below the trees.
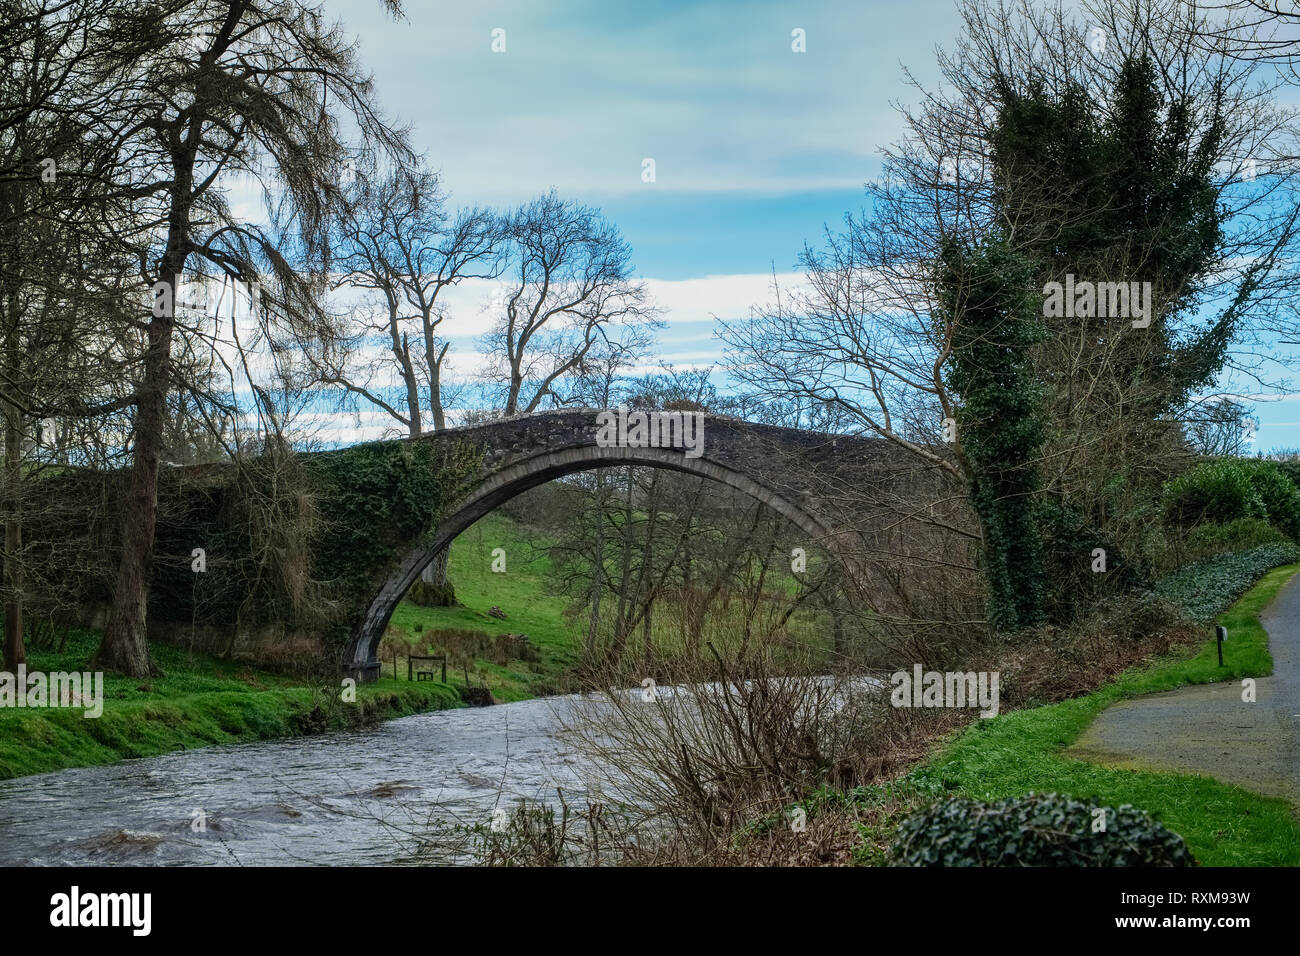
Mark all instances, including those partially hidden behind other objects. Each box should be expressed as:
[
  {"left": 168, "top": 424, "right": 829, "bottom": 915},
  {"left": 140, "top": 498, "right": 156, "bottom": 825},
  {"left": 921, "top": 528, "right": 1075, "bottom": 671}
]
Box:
[{"left": 0, "top": 631, "right": 459, "bottom": 779}]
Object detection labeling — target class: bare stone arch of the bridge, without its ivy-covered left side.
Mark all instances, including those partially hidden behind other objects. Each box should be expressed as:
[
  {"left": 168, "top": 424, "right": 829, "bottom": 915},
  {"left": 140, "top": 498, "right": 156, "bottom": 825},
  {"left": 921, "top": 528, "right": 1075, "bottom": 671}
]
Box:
[{"left": 343, "top": 408, "right": 913, "bottom": 682}]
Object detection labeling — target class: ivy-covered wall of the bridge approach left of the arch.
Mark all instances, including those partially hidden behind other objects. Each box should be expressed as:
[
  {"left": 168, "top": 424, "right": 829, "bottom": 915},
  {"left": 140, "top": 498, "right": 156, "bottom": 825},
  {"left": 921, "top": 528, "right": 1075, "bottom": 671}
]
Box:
[{"left": 29, "top": 440, "right": 482, "bottom": 649}]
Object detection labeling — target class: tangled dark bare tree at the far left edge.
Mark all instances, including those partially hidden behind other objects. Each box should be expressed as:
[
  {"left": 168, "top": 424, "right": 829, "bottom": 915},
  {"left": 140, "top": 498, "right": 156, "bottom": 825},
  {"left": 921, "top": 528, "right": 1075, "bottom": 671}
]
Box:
[{"left": 0, "top": 0, "right": 157, "bottom": 669}]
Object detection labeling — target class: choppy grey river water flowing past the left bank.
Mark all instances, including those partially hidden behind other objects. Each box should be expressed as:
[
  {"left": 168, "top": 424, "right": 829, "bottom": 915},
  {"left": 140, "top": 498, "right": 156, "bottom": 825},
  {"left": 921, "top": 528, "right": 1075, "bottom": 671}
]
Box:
[{"left": 0, "top": 697, "right": 598, "bottom": 866}]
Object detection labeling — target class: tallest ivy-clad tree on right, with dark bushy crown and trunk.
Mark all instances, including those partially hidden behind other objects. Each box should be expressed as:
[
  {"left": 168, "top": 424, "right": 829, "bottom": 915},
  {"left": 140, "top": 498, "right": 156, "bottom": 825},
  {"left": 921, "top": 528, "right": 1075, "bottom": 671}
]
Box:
[{"left": 991, "top": 49, "right": 1253, "bottom": 606}]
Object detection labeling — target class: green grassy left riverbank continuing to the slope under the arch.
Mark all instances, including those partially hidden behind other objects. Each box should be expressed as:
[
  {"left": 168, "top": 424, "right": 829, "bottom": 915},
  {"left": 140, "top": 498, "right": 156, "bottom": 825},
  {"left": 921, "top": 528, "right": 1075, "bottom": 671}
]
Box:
[{"left": 0, "top": 515, "right": 577, "bottom": 779}]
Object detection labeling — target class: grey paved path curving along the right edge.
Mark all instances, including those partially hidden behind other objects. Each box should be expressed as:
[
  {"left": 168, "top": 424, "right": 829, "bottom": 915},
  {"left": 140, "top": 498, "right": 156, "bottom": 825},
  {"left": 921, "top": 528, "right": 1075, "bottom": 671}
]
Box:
[{"left": 1066, "top": 575, "right": 1300, "bottom": 805}]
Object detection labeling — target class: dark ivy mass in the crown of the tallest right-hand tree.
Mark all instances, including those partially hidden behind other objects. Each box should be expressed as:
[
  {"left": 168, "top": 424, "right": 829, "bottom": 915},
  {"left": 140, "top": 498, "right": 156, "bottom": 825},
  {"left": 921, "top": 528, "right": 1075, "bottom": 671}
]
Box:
[{"left": 992, "top": 52, "right": 1232, "bottom": 420}]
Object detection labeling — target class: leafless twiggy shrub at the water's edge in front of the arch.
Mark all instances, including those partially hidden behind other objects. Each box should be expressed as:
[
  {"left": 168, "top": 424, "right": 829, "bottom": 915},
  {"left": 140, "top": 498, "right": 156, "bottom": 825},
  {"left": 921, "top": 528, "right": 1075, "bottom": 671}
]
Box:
[{"left": 560, "top": 636, "right": 946, "bottom": 858}]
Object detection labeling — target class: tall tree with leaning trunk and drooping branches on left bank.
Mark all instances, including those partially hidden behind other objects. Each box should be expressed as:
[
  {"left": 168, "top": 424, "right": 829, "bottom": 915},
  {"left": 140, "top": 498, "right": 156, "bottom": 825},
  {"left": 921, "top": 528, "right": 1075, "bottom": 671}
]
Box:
[{"left": 89, "top": 0, "right": 411, "bottom": 675}]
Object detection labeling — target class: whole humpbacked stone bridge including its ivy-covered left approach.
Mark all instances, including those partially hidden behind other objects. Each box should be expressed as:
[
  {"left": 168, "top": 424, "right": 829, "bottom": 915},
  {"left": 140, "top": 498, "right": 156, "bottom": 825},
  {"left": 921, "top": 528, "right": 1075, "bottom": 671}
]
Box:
[{"left": 50, "top": 408, "right": 930, "bottom": 680}]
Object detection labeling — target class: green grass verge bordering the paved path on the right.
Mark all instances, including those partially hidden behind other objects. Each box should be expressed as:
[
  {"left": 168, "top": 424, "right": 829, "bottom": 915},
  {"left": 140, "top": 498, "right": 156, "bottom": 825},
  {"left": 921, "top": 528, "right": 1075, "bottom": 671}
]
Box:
[{"left": 909, "top": 564, "right": 1300, "bottom": 866}]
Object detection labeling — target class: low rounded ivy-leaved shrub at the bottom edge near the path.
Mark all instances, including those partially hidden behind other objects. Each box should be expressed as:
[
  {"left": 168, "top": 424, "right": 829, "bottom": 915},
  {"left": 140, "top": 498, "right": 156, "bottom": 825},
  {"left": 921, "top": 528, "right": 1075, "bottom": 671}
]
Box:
[{"left": 891, "top": 793, "right": 1195, "bottom": 866}]
